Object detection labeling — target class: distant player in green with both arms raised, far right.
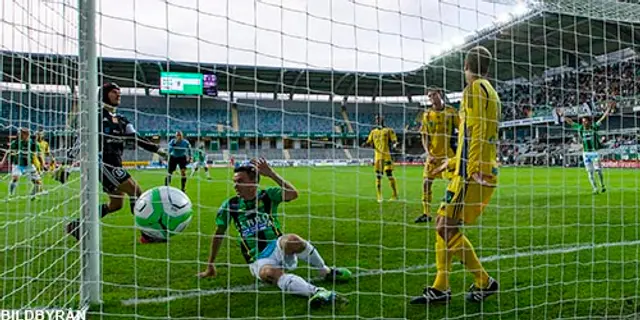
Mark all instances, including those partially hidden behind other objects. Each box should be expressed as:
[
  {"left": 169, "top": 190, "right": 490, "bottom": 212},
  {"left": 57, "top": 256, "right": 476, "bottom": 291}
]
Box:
[{"left": 557, "top": 106, "right": 611, "bottom": 194}]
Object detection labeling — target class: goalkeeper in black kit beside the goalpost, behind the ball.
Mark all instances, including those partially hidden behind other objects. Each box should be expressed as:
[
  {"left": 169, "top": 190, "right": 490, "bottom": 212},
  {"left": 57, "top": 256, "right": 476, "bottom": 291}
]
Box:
[{"left": 66, "top": 82, "right": 166, "bottom": 243}]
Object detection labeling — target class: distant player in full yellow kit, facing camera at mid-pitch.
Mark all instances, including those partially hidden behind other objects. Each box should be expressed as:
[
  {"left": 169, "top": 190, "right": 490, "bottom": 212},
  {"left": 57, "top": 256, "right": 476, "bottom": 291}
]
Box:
[{"left": 363, "top": 115, "right": 398, "bottom": 202}]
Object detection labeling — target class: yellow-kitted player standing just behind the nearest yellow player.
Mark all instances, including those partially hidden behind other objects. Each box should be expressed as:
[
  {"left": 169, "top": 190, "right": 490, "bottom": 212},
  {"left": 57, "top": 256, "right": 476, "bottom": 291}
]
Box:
[{"left": 415, "top": 90, "right": 459, "bottom": 223}]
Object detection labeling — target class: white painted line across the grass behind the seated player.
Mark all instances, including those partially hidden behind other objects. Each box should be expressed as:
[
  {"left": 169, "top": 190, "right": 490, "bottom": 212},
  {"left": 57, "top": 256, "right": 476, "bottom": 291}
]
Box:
[{"left": 122, "top": 240, "right": 640, "bottom": 306}]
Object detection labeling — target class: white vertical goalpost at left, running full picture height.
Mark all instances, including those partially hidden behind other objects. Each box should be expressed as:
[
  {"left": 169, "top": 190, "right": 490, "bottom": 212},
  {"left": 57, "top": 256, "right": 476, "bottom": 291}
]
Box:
[{"left": 78, "top": 0, "right": 102, "bottom": 306}]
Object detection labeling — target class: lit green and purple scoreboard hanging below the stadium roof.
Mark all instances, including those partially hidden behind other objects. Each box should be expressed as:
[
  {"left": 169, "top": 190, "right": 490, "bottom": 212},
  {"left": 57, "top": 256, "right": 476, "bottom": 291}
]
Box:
[{"left": 160, "top": 72, "right": 218, "bottom": 97}]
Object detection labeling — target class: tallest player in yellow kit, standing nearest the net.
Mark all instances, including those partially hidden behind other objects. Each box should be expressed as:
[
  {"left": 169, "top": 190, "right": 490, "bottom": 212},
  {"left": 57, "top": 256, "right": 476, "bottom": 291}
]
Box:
[{"left": 411, "top": 47, "right": 501, "bottom": 304}]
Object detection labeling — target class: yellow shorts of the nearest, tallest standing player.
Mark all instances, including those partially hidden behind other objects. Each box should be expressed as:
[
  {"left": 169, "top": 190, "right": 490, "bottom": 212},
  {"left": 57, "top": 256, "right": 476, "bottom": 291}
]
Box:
[{"left": 438, "top": 176, "right": 497, "bottom": 224}]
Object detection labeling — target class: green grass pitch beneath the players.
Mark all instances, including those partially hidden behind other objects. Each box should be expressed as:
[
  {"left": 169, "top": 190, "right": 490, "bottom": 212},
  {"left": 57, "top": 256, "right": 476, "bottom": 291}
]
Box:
[{"left": 0, "top": 167, "right": 640, "bottom": 319}]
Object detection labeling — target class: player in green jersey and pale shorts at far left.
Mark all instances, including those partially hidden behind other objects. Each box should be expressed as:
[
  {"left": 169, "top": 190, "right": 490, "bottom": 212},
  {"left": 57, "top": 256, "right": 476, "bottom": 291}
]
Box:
[{"left": 0, "top": 128, "right": 44, "bottom": 200}]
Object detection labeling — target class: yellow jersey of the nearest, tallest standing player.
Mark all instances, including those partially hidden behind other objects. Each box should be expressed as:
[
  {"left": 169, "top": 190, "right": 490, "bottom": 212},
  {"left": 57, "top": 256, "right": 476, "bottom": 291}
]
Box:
[{"left": 455, "top": 78, "right": 501, "bottom": 178}]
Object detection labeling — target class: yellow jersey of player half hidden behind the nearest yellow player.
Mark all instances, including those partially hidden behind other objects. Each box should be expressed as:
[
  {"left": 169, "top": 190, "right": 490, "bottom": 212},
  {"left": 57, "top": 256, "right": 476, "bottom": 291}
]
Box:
[{"left": 420, "top": 106, "right": 460, "bottom": 158}]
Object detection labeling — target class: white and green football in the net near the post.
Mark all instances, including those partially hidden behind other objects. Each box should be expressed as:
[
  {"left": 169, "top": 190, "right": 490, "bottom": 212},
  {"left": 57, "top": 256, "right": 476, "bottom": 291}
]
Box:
[{"left": 134, "top": 186, "right": 193, "bottom": 239}]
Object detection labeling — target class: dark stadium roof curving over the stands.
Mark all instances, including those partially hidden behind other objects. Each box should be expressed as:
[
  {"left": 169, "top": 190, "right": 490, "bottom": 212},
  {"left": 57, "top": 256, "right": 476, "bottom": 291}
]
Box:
[{"left": 0, "top": 0, "right": 640, "bottom": 96}]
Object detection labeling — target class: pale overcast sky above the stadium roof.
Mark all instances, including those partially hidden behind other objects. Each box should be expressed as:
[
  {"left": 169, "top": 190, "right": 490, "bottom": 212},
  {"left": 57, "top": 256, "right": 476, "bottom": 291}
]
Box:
[{"left": 0, "top": 0, "right": 512, "bottom": 72}]
